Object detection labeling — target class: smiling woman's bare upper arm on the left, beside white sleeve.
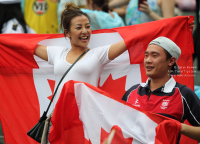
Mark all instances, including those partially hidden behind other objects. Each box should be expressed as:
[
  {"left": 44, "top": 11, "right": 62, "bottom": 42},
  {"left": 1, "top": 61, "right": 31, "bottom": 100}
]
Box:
[{"left": 34, "top": 45, "right": 48, "bottom": 61}]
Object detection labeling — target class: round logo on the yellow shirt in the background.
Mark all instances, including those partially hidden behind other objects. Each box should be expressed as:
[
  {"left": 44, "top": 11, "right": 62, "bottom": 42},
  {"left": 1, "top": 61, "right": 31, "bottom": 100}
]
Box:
[{"left": 33, "top": 0, "right": 48, "bottom": 15}]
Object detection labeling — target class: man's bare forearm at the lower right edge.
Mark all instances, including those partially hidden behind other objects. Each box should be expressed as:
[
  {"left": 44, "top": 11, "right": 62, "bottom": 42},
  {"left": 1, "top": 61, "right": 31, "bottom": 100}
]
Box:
[{"left": 180, "top": 123, "right": 200, "bottom": 142}]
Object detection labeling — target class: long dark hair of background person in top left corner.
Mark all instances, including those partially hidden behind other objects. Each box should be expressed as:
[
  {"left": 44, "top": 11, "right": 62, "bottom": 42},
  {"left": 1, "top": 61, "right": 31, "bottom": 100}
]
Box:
[{"left": 0, "top": 3, "right": 27, "bottom": 33}]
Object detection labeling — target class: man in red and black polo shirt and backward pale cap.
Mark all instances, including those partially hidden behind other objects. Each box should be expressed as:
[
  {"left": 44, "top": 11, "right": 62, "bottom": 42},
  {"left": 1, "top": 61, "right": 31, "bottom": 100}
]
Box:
[{"left": 122, "top": 37, "right": 200, "bottom": 141}]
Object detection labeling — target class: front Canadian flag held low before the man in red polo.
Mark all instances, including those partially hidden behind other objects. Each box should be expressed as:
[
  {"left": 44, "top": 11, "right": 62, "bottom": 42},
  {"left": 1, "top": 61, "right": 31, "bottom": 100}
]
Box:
[{"left": 49, "top": 81, "right": 181, "bottom": 144}]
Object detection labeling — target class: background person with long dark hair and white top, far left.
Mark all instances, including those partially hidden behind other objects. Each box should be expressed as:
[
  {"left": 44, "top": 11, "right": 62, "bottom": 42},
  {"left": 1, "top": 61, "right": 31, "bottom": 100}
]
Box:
[{"left": 0, "top": 0, "right": 35, "bottom": 34}]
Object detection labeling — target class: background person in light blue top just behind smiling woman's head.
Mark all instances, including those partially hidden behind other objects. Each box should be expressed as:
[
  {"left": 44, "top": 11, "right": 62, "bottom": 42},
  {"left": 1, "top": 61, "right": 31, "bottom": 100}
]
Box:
[{"left": 81, "top": 0, "right": 124, "bottom": 30}]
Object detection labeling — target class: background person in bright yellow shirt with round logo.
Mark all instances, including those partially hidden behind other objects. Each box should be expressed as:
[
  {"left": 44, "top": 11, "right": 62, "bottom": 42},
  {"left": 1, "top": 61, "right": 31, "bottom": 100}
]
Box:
[{"left": 21, "top": 0, "right": 58, "bottom": 34}]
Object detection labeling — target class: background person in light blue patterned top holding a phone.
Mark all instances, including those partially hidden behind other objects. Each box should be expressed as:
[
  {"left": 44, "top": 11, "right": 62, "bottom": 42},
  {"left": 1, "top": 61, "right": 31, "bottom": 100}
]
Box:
[{"left": 109, "top": 0, "right": 175, "bottom": 25}]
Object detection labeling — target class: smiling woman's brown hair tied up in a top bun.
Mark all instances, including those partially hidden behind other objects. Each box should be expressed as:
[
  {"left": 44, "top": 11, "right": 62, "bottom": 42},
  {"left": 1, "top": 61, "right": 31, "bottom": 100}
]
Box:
[{"left": 60, "top": 2, "right": 90, "bottom": 31}]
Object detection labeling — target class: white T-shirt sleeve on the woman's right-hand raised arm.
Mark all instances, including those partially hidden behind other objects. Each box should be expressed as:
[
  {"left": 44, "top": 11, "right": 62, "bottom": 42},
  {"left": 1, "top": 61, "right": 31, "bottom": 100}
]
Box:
[{"left": 95, "top": 45, "right": 111, "bottom": 65}]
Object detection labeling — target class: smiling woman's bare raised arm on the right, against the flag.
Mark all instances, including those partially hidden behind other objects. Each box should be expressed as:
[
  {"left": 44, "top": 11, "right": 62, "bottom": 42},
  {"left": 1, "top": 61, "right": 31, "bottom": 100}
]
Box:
[{"left": 108, "top": 40, "right": 126, "bottom": 60}]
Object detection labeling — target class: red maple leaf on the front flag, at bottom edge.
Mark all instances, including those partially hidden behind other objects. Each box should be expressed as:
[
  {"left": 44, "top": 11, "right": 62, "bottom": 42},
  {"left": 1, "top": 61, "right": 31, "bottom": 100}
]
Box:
[{"left": 101, "top": 125, "right": 133, "bottom": 144}]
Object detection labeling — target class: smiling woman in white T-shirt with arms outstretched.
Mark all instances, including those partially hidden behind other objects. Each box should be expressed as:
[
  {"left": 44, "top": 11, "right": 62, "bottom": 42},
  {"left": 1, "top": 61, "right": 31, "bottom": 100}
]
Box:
[{"left": 35, "top": 3, "right": 126, "bottom": 106}]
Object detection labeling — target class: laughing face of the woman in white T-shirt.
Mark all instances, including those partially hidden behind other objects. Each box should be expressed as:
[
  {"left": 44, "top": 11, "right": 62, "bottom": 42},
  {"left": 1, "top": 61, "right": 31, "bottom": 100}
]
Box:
[{"left": 66, "top": 15, "right": 92, "bottom": 48}]
